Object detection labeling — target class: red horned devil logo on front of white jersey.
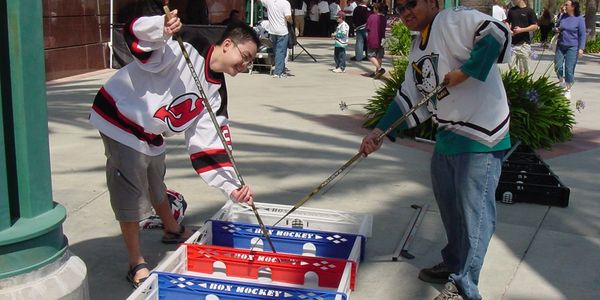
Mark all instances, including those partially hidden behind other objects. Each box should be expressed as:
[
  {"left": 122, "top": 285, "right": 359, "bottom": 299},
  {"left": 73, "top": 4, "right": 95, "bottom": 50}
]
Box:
[{"left": 154, "top": 93, "right": 204, "bottom": 132}]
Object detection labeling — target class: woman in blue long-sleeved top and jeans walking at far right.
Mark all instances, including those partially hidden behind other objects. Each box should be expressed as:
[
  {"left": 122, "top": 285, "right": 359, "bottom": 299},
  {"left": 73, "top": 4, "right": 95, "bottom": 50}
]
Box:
[{"left": 554, "top": 0, "right": 585, "bottom": 99}]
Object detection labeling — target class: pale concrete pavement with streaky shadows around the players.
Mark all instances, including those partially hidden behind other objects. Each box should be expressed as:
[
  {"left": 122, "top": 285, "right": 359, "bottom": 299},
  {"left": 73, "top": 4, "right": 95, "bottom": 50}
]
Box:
[{"left": 47, "top": 38, "right": 600, "bottom": 299}]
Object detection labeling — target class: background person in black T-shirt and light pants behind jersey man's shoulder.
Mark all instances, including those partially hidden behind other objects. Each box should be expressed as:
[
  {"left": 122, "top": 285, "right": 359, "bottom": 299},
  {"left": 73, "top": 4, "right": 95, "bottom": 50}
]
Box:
[{"left": 506, "top": 0, "right": 538, "bottom": 74}]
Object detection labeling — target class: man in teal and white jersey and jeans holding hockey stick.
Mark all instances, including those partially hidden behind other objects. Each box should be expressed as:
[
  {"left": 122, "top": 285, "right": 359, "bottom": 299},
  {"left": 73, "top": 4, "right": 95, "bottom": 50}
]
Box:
[{"left": 360, "top": 0, "right": 511, "bottom": 299}]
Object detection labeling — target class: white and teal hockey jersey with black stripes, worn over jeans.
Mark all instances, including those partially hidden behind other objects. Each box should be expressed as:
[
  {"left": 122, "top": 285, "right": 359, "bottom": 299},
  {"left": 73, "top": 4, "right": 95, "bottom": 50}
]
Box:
[{"left": 377, "top": 7, "right": 511, "bottom": 154}]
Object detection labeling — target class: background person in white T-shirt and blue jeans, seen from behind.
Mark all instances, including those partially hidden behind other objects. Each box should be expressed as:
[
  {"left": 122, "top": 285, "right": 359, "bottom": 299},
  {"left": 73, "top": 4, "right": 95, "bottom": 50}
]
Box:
[{"left": 260, "top": 0, "right": 292, "bottom": 78}]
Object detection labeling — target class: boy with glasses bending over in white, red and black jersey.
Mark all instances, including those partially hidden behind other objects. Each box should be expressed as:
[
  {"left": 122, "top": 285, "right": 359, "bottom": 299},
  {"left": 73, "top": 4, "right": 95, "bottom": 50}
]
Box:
[{"left": 90, "top": 10, "right": 259, "bottom": 287}]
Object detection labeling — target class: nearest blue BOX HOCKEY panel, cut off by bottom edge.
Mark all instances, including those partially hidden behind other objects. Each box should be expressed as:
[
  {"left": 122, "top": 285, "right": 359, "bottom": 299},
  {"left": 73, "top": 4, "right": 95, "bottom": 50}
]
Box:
[{"left": 128, "top": 272, "right": 347, "bottom": 300}]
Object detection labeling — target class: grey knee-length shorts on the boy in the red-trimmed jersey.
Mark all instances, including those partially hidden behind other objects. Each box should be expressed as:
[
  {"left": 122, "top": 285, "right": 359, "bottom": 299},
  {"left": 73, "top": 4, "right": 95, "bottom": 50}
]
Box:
[{"left": 100, "top": 133, "right": 167, "bottom": 222}]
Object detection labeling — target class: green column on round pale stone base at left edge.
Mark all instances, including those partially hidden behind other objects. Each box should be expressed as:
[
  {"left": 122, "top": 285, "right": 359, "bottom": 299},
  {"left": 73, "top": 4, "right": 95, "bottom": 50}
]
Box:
[{"left": 0, "top": 0, "right": 67, "bottom": 279}]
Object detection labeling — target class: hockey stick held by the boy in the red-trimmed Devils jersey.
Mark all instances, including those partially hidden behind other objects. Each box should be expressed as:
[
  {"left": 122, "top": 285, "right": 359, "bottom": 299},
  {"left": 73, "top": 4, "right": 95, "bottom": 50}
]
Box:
[{"left": 163, "top": 1, "right": 277, "bottom": 253}]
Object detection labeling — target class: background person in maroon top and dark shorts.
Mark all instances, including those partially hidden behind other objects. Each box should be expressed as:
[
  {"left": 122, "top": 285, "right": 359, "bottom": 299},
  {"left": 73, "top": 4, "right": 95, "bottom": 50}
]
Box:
[{"left": 366, "top": 3, "right": 386, "bottom": 79}]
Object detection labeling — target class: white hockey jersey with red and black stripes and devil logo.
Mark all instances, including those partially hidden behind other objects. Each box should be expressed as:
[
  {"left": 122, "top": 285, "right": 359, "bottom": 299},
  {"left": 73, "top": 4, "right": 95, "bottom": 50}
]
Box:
[{"left": 90, "top": 16, "right": 240, "bottom": 195}]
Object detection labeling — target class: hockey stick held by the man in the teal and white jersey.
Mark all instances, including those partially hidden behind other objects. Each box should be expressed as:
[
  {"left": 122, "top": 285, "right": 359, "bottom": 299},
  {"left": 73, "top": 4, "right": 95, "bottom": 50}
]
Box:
[{"left": 273, "top": 83, "right": 446, "bottom": 227}]
